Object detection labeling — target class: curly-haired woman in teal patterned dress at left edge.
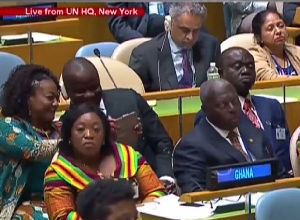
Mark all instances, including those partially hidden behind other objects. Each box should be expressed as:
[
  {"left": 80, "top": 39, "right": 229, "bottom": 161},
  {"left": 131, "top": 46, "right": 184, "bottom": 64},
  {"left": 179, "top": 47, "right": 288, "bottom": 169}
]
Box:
[{"left": 0, "top": 64, "right": 60, "bottom": 220}]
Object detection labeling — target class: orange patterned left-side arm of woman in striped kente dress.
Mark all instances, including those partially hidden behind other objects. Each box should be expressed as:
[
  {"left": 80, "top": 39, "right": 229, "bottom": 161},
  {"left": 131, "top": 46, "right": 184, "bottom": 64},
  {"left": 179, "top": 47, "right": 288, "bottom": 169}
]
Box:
[{"left": 44, "top": 166, "right": 82, "bottom": 220}]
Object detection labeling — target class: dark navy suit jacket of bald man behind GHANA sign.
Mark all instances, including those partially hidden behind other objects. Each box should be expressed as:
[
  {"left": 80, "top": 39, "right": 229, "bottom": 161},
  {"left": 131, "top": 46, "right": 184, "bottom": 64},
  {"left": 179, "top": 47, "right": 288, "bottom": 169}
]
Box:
[{"left": 173, "top": 115, "right": 286, "bottom": 193}]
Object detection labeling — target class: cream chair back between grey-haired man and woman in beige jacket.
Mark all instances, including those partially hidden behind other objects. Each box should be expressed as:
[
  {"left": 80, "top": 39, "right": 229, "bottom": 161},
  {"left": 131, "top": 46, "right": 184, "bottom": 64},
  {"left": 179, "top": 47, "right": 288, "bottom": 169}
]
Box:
[{"left": 221, "top": 33, "right": 255, "bottom": 52}]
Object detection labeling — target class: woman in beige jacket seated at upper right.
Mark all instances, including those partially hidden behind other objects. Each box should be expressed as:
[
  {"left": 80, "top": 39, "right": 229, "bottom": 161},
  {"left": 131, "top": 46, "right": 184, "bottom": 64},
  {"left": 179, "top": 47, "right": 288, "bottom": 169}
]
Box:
[{"left": 249, "top": 11, "right": 300, "bottom": 80}]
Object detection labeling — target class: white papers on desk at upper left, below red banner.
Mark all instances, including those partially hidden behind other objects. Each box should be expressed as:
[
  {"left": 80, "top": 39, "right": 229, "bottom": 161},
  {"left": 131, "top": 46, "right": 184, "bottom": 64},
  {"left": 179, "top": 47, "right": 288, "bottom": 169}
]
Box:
[{"left": 1, "top": 32, "right": 60, "bottom": 42}]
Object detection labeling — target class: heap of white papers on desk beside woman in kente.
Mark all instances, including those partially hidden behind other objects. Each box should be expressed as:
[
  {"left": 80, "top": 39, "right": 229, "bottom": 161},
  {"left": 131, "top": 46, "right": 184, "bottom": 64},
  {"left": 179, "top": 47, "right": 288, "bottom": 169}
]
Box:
[{"left": 137, "top": 195, "right": 213, "bottom": 220}]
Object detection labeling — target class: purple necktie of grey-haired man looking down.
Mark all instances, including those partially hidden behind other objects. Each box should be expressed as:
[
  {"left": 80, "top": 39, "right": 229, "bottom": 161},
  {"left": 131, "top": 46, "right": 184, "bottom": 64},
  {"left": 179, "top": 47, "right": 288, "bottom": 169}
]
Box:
[{"left": 179, "top": 50, "right": 193, "bottom": 88}]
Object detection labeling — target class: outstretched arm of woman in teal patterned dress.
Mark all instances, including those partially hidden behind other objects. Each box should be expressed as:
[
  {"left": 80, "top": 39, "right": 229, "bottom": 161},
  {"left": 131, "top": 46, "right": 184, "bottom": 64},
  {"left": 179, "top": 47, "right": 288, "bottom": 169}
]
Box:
[{"left": 0, "top": 117, "right": 58, "bottom": 160}]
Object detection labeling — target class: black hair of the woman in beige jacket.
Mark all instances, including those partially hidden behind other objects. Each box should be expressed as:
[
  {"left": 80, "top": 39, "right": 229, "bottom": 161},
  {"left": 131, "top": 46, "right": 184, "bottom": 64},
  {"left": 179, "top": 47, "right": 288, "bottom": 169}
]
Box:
[{"left": 252, "top": 9, "right": 284, "bottom": 46}]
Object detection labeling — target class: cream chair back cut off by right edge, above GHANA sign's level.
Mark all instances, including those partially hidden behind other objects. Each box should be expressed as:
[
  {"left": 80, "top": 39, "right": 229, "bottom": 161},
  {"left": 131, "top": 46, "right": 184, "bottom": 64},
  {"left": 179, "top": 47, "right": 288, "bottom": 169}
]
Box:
[{"left": 290, "top": 127, "right": 300, "bottom": 177}]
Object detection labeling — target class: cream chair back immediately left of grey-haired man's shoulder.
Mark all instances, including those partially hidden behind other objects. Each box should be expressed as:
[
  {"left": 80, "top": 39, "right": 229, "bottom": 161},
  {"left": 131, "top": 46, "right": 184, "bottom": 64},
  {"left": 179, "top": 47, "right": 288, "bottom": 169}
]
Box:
[{"left": 111, "top": 38, "right": 151, "bottom": 65}]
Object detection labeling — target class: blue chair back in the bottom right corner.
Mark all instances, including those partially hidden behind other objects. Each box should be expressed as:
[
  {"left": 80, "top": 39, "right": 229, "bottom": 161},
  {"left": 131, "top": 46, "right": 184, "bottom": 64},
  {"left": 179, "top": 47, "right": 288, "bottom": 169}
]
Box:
[{"left": 255, "top": 188, "right": 300, "bottom": 220}]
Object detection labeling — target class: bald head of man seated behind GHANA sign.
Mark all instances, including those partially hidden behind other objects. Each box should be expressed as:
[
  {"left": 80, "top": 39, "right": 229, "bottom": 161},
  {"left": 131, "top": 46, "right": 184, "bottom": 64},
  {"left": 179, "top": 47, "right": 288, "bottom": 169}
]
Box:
[{"left": 200, "top": 79, "right": 241, "bottom": 130}]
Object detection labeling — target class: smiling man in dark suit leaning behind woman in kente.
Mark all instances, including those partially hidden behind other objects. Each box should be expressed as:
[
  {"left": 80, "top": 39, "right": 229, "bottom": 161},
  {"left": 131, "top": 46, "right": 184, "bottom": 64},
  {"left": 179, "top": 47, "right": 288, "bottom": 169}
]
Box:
[{"left": 62, "top": 58, "right": 174, "bottom": 191}]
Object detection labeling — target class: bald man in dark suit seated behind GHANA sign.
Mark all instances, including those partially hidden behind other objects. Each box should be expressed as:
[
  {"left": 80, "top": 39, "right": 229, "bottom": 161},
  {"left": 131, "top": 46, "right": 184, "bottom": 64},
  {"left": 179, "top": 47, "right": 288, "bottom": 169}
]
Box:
[{"left": 173, "top": 79, "right": 274, "bottom": 193}]
